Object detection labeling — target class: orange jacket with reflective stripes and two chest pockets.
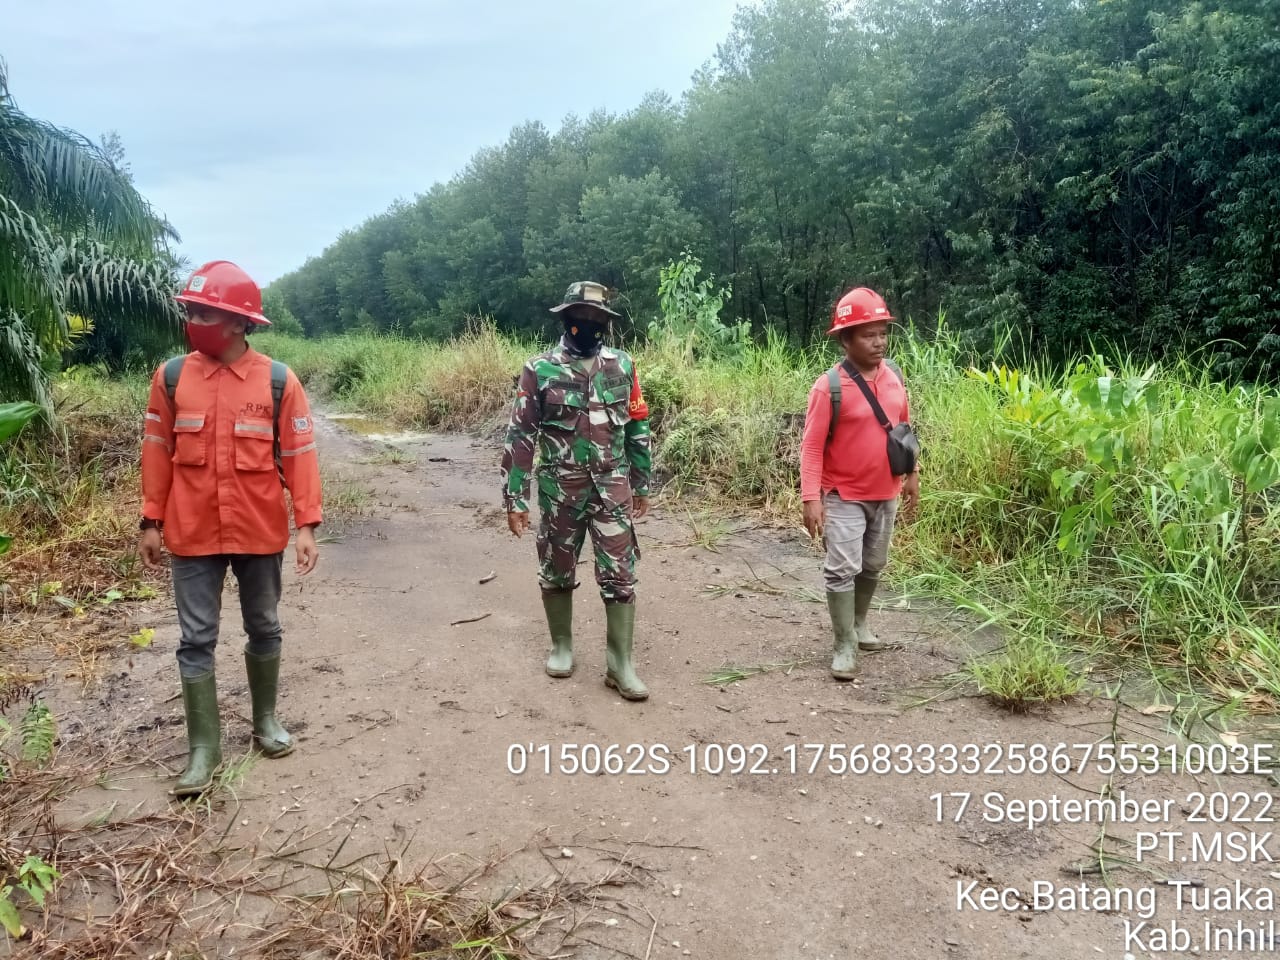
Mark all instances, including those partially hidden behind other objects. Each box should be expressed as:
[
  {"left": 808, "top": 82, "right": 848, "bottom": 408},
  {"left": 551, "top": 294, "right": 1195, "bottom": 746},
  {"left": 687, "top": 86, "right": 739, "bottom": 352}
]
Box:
[{"left": 142, "top": 348, "right": 323, "bottom": 557}]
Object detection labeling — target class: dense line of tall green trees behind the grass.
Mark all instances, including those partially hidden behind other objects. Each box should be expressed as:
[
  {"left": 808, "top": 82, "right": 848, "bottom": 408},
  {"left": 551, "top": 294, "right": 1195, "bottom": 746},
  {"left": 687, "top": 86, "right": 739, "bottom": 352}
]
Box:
[{"left": 274, "top": 0, "right": 1280, "bottom": 376}]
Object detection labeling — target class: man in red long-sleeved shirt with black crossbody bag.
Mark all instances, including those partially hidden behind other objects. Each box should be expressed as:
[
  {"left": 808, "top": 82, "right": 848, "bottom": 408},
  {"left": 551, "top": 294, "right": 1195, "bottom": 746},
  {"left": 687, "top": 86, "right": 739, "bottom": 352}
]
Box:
[{"left": 800, "top": 287, "right": 920, "bottom": 680}]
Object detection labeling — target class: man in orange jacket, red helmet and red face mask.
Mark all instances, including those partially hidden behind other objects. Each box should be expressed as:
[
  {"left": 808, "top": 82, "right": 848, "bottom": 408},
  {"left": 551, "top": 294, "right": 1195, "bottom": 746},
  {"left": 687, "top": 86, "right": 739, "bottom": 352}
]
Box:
[{"left": 140, "top": 260, "right": 321, "bottom": 796}]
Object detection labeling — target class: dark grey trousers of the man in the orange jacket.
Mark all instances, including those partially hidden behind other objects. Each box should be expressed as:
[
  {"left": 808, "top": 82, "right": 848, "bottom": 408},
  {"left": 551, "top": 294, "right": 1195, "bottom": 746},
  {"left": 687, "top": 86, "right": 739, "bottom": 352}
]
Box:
[{"left": 170, "top": 553, "right": 284, "bottom": 677}]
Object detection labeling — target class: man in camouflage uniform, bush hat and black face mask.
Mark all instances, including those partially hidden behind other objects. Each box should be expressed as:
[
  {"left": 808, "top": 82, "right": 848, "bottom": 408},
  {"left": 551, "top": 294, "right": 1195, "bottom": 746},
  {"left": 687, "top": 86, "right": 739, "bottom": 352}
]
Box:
[{"left": 502, "top": 282, "right": 650, "bottom": 700}]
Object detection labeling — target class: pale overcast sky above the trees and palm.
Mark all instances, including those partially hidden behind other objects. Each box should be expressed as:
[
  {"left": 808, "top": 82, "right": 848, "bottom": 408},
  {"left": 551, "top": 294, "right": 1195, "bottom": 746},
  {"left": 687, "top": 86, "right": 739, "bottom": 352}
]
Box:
[{"left": 0, "top": 0, "right": 739, "bottom": 284}]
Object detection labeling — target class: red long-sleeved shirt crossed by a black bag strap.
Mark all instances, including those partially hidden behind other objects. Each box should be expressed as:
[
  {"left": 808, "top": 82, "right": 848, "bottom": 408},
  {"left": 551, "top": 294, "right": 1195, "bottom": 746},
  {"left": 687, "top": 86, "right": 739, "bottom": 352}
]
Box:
[{"left": 800, "top": 364, "right": 911, "bottom": 500}]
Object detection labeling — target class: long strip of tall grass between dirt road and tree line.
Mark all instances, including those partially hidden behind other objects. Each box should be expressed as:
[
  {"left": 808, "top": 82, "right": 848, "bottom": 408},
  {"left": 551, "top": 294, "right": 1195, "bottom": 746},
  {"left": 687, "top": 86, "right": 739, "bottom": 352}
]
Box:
[{"left": 259, "top": 317, "right": 1280, "bottom": 707}]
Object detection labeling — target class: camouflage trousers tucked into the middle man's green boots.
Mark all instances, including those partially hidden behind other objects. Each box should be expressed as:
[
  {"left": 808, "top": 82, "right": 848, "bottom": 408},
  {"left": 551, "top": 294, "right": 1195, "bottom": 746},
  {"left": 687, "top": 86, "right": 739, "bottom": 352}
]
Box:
[{"left": 538, "top": 472, "right": 640, "bottom": 603}]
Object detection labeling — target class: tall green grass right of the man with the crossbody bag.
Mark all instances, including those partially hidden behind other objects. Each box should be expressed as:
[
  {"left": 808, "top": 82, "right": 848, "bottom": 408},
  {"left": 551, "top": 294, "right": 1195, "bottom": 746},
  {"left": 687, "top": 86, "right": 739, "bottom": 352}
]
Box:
[{"left": 900, "top": 337, "right": 1280, "bottom": 699}]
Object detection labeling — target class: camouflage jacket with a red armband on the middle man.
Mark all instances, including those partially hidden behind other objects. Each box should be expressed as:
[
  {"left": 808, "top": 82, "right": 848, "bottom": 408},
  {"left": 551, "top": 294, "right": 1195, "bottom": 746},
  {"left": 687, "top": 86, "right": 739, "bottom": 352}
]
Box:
[{"left": 502, "top": 340, "right": 652, "bottom": 511}]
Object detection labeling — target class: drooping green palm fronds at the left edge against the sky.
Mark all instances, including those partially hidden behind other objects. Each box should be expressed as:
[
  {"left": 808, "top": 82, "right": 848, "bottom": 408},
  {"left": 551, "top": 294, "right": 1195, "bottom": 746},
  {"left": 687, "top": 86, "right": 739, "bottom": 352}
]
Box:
[{"left": 0, "top": 60, "right": 182, "bottom": 415}]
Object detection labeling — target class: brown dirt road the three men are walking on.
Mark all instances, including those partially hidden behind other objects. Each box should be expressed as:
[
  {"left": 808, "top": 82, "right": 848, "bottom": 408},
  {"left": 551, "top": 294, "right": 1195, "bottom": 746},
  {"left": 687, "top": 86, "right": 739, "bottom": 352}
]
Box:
[{"left": 35, "top": 422, "right": 1280, "bottom": 960}]
